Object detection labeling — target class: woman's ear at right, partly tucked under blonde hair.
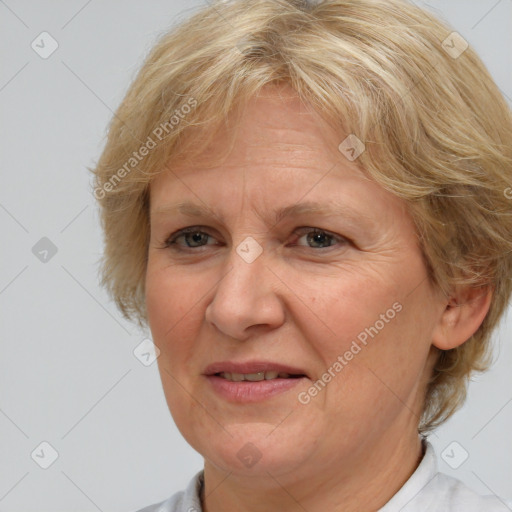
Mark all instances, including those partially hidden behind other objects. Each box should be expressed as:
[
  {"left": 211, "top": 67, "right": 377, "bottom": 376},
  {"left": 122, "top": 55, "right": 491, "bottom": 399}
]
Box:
[{"left": 432, "top": 286, "right": 492, "bottom": 350}]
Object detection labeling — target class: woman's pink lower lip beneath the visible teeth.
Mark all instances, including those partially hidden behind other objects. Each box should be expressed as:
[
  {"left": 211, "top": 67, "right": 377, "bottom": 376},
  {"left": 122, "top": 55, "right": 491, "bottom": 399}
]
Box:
[{"left": 207, "top": 375, "right": 306, "bottom": 403}]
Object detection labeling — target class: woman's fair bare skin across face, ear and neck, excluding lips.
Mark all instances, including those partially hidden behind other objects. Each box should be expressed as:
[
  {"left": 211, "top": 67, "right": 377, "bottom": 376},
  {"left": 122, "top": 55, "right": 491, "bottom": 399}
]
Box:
[{"left": 145, "top": 87, "right": 490, "bottom": 512}]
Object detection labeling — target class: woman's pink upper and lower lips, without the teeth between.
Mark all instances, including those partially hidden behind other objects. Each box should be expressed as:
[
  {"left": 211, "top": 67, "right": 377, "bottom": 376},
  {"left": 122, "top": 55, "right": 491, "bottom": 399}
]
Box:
[{"left": 204, "top": 361, "right": 307, "bottom": 403}]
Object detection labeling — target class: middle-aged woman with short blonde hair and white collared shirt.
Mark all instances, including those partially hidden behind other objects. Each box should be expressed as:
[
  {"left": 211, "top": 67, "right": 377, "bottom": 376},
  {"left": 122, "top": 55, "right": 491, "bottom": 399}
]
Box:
[{"left": 95, "top": 0, "right": 512, "bottom": 512}]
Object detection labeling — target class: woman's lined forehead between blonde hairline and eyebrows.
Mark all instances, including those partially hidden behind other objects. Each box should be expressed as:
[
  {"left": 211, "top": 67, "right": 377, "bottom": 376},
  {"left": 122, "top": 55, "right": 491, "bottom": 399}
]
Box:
[{"left": 150, "top": 83, "right": 408, "bottom": 226}]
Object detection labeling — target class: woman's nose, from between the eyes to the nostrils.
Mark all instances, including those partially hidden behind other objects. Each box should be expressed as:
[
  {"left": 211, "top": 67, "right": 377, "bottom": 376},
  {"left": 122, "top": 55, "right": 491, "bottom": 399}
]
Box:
[{"left": 205, "top": 240, "right": 285, "bottom": 341}]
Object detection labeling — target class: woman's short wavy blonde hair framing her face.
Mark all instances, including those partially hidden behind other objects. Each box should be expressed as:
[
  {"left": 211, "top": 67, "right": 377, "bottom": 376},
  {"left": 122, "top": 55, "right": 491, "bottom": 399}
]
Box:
[{"left": 89, "top": 0, "right": 512, "bottom": 433}]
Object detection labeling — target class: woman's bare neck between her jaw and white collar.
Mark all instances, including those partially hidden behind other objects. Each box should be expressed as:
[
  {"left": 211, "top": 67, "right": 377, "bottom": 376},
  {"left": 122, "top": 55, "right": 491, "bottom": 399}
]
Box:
[{"left": 202, "top": 431, "right": 423, "bottom": 512}]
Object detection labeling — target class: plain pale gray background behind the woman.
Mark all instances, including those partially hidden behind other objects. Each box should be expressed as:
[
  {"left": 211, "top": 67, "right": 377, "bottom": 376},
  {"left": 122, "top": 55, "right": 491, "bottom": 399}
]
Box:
[{"left": 0, "top": 0, "right": 512, "bottom": 512}]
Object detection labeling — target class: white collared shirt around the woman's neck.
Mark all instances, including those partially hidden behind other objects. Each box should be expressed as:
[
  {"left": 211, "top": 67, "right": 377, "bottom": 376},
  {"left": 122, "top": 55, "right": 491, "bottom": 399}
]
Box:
[{"left": 138, "top": 441, "right": 512, "bottom": 512}]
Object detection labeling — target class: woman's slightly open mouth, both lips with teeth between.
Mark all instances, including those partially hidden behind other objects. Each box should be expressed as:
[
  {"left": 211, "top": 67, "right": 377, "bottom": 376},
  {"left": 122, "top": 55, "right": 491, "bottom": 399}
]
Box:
[{"left": 204, "top": 361, "right": 308, "bottom": 403}]
